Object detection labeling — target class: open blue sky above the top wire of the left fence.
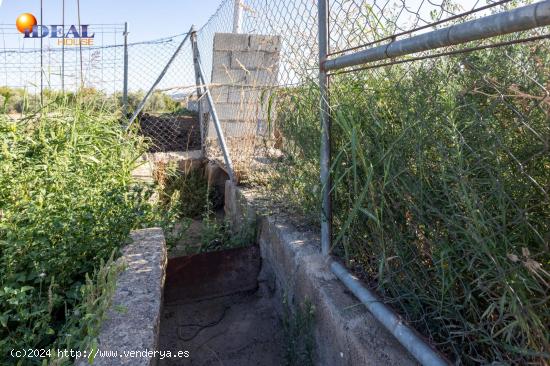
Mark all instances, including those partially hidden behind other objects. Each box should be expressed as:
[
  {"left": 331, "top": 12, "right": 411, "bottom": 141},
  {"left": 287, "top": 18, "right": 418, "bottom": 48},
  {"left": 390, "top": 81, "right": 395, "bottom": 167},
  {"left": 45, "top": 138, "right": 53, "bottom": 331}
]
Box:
[{"left": 0, "top": 0, "right": 221, "bottom": 42}]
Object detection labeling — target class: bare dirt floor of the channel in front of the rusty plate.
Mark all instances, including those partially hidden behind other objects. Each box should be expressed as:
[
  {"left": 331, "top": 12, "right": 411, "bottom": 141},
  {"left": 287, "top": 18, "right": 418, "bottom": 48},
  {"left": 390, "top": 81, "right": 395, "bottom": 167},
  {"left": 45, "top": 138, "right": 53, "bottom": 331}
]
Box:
[{"left": 159, "top": 292, "right": 284, "bottom": 366}]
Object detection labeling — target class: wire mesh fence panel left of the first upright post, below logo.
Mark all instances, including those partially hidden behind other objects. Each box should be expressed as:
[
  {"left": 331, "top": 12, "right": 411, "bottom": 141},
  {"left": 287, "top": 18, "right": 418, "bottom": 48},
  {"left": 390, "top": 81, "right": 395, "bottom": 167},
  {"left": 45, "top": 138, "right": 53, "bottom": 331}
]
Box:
[{"left": 0, "top": 24, "right": 124, "bottom": 113}]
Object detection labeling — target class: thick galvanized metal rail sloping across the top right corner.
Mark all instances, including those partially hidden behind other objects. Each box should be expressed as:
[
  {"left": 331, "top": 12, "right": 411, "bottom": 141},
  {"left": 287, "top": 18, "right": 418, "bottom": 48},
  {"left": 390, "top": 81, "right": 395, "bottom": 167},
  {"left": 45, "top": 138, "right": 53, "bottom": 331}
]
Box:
[{"left": 325, "top": 0, "right": 550, "bottom": 70}]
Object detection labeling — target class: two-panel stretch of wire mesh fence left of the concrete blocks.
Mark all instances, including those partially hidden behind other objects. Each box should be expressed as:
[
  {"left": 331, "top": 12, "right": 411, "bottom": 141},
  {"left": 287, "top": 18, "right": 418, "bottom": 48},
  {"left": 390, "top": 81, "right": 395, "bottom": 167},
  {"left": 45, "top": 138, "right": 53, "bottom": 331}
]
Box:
[{"left": 0, "top": 24, "right": 201, "bottom": 152}]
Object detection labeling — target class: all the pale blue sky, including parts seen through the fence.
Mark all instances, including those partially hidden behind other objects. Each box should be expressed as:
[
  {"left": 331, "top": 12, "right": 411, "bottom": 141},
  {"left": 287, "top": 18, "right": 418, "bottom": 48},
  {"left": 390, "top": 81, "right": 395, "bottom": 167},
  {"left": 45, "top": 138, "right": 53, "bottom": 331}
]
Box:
[{"left": 0, "top": 0, "right": 487, "bottom": 91}]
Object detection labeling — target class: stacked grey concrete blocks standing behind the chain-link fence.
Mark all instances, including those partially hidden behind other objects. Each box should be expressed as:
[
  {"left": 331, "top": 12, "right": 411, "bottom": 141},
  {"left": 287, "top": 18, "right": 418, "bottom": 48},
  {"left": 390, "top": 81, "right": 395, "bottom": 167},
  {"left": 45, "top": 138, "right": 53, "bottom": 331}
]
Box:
[{"left": 203, "top": 33, "right": 281, "bottom": 169}]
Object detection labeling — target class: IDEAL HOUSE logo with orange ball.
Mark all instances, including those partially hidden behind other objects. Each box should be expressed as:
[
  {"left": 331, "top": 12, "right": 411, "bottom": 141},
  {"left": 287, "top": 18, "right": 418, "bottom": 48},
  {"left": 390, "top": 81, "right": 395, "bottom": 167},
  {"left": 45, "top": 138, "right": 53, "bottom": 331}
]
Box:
[{"left": 15, "top": 12, "right": 95, "bottom": 46}]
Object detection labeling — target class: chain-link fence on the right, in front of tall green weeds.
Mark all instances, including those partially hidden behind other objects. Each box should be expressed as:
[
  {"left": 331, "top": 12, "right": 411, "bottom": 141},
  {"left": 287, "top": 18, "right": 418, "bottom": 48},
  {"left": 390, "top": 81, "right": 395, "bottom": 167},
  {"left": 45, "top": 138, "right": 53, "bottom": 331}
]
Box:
[{"left": 193, "top": 0, "right": 550, "bottom": 364}]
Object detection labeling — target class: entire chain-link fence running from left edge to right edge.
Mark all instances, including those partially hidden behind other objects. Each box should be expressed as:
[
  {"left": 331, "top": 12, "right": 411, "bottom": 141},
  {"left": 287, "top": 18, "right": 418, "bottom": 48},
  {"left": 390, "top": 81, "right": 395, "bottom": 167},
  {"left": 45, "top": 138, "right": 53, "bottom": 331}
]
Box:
[{"left": 0, "top": 0, "right": 550, "bottom": 364}]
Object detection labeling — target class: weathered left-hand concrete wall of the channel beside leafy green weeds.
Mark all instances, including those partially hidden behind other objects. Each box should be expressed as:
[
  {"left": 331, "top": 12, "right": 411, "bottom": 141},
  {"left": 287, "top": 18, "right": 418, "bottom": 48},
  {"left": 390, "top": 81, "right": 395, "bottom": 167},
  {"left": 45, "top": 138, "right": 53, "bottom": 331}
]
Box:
[{"left": 76, "top": 228, "right": 167, "bottom": 366}]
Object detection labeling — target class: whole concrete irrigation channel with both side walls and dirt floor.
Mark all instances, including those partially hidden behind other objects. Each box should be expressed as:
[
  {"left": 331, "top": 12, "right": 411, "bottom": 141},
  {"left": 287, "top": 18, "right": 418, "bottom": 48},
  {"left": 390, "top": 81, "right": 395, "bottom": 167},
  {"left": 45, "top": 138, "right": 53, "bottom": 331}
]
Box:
[{"left": 91, "top": 152, "right": 417, "bottom": 366}]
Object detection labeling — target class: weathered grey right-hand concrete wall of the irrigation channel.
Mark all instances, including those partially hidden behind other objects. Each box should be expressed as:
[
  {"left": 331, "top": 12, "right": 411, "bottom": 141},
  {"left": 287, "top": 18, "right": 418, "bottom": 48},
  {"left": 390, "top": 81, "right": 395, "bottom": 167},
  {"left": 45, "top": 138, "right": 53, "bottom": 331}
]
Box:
[{"left": 225, "top": 182, "right": 416, "bottom": 366}]
